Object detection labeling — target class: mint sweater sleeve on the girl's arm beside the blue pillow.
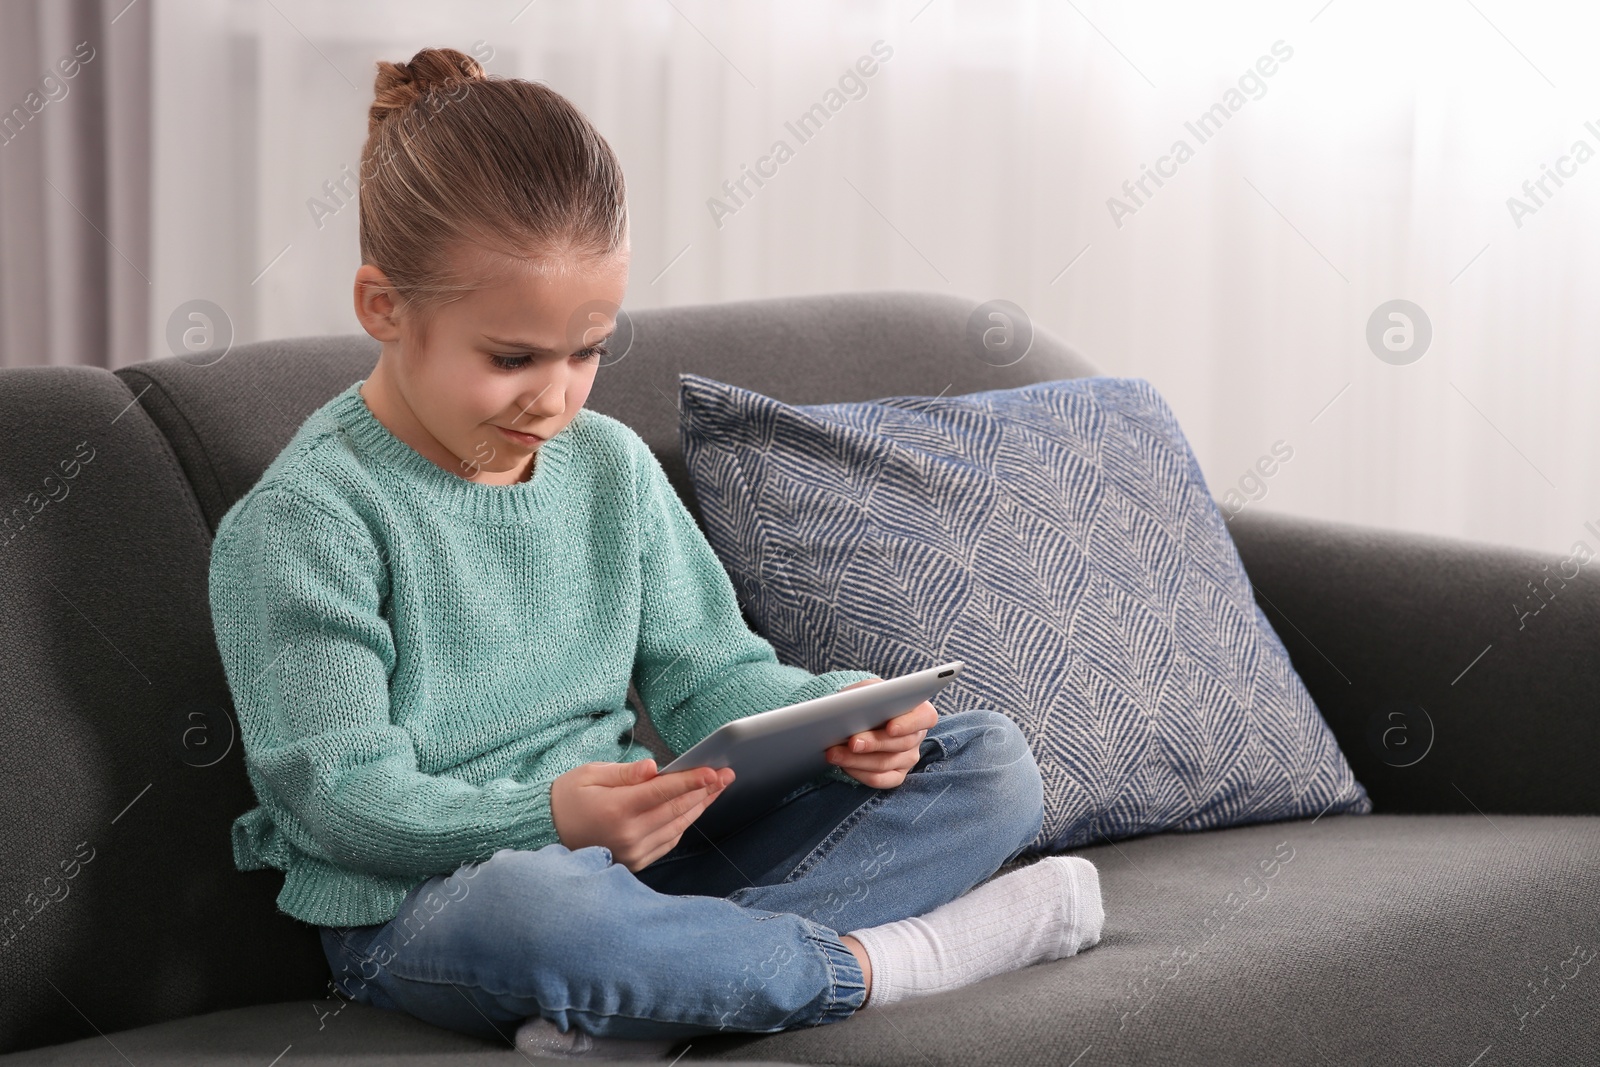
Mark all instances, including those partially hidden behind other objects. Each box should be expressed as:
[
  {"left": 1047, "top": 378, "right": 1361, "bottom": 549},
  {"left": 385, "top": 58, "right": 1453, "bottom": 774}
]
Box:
[{"left": 634, "top": 442, "right": 877, "bottom": 752}]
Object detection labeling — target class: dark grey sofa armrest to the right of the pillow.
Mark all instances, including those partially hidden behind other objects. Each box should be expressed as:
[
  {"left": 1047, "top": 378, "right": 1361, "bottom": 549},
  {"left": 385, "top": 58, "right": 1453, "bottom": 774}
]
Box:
[{"left": 1229, "top": 510, "right": 1600, "bottom": 816}]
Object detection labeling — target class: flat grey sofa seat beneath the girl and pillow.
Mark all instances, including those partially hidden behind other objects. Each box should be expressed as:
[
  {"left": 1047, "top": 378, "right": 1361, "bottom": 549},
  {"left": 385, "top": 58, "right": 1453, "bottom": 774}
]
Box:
[{"left": 9, "top": 814, "right": 1600, "bottom": 1067}]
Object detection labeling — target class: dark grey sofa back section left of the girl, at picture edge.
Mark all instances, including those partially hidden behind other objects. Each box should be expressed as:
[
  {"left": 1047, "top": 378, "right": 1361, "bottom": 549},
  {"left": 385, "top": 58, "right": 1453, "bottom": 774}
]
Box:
[{"left": 0, "top": 368, "right": 325, "bottom": 1053}]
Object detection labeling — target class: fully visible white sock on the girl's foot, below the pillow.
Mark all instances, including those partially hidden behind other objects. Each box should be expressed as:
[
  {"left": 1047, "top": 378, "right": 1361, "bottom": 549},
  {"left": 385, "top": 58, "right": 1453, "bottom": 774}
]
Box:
[{"left": 850, "top": 856, "right": 1106, "bottom": 1009}]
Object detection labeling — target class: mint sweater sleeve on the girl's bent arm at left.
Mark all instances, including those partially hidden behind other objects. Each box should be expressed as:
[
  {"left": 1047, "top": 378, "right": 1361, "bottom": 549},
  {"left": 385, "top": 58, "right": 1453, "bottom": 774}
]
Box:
[{"left": 210, "top": 490, "right": 557, "bottom": 877}]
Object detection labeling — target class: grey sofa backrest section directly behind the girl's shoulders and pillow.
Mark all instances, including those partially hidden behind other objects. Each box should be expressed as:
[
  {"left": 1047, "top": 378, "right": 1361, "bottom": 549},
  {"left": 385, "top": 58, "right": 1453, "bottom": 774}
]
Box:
[{"left": 117, "top": 293, "right": 1096, "bottom": 530}]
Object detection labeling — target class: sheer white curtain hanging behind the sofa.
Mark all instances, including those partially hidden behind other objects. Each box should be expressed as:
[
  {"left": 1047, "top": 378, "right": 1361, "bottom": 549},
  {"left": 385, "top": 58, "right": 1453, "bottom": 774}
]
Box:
[{"left": 150, "top": 0, "right": 1600, "bottom": 555}]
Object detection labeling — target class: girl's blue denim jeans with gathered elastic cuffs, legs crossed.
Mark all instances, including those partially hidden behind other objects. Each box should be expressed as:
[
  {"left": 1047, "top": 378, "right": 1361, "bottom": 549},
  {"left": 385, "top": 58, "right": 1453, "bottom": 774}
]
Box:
[{"left": 320, "top": 709, "right": 1045, "bottom": 1040}]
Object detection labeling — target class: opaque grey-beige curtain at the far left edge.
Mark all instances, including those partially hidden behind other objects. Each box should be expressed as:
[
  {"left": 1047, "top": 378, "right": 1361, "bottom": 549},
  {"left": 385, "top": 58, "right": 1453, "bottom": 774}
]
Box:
[{"left": 0, "top": 0, "right": 155, "bottom": 366}]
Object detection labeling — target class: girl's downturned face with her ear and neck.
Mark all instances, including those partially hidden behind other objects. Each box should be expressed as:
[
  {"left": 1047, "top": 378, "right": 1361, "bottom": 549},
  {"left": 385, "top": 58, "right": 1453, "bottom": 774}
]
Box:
[{"left": 355, "top": 251, "right": 629, "bottom": 485}]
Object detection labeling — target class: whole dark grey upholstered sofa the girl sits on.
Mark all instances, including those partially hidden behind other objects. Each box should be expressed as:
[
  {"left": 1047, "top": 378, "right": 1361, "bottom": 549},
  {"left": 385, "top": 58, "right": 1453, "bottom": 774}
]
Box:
[{"left": 0, "top": 293, "right": 1600, "bottom": 1067}]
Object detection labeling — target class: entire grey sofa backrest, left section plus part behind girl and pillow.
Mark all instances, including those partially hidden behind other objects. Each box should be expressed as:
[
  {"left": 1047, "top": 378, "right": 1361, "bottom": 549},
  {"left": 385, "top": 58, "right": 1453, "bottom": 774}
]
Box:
[{"left": 0, "top": 293, "right": 1093, "bottom": 1053}]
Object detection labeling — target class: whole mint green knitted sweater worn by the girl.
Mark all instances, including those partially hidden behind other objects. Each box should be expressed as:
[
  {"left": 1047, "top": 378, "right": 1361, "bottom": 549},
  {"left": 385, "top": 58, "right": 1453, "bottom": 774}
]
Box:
[{"left": 210, "top": 382, "right": 877, "bottom": 926}]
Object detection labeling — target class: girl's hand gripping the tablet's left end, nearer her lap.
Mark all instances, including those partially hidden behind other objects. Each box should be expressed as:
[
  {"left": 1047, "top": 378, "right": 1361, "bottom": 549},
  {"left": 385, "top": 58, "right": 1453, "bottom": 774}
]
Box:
[{"left": 550, "top": 760, "right": 733, "bottom": 873}]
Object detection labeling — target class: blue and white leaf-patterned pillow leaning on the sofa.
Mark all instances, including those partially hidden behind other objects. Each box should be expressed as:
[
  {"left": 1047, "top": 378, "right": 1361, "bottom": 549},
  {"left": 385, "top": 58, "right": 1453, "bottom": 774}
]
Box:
[{"left": 678, "top": 374, "right": 1373, "bottom": 851}]
